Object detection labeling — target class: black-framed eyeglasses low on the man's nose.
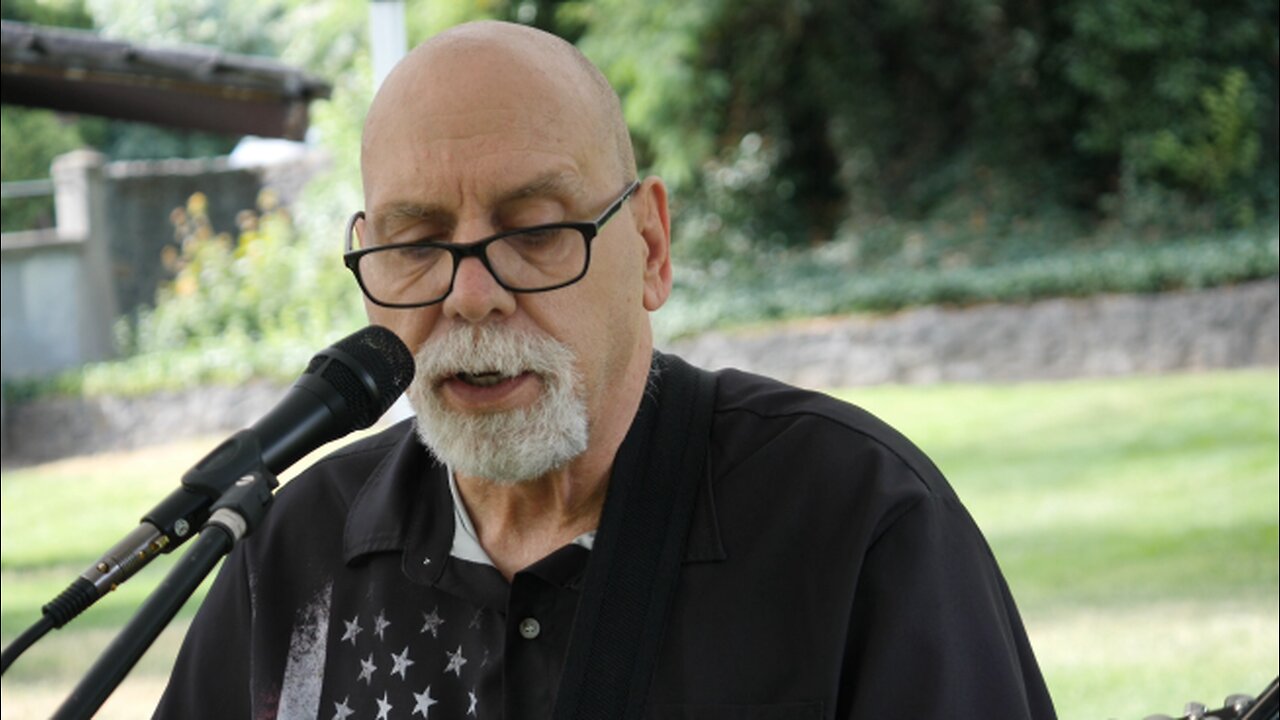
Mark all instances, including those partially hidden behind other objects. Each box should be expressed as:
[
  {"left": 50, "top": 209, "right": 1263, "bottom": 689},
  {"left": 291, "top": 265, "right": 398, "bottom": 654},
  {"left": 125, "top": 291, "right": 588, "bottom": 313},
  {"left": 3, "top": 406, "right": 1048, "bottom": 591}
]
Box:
[{"left": 342, "top": 181, "right": 640, "bottom": 307}]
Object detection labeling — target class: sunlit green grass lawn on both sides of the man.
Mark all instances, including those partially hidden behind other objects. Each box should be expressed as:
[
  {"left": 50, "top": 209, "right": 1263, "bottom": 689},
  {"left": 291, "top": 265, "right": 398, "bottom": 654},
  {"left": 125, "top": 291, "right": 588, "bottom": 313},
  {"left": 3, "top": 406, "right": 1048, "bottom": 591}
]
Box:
[{"left": 0, "top": 370, "right": 1280, "bottom": 720}]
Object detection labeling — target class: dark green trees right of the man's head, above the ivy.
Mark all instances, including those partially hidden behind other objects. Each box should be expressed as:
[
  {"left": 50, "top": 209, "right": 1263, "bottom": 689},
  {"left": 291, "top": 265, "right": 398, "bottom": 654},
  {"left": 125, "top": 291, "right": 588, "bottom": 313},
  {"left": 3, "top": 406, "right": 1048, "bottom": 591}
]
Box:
[{"left": 570, "top": 0, "right": 1277, "bottom": 251}]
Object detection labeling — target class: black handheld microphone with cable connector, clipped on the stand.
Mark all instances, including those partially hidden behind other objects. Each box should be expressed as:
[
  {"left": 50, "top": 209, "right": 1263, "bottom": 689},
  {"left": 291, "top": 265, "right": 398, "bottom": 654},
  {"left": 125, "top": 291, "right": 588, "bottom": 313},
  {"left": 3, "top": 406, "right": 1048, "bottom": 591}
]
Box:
[{"left": 41, "top": 325, "right": 413, "bottom": 628}]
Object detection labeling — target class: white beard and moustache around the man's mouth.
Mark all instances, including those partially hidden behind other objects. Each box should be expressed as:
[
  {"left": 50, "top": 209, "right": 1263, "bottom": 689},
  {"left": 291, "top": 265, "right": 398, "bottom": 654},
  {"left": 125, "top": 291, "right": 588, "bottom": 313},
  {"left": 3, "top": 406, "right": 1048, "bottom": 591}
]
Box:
[{"left": 407, "top": 324, "right": 588, "bottom": 486}]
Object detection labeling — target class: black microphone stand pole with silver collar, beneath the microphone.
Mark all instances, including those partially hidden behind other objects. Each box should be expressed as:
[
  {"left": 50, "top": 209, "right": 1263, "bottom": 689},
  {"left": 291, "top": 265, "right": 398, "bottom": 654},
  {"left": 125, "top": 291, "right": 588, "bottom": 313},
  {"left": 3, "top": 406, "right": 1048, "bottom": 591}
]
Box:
[{"left": 52, "top": 469, "right": 279, "bottom": 720}]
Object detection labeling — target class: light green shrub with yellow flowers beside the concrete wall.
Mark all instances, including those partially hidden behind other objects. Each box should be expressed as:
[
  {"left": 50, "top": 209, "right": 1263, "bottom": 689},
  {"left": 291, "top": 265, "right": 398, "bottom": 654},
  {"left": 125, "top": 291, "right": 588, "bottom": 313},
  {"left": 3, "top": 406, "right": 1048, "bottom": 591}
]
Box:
[{"left": 99, "top": 191, "right": 364, "bottom": 392}]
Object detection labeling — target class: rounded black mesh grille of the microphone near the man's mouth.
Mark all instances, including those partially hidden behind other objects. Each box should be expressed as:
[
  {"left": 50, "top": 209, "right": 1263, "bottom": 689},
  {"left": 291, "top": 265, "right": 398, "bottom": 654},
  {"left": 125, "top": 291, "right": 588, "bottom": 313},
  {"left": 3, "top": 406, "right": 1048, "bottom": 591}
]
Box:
[{"left": 306, "top": 325, "right": 413, "bottom": 429}]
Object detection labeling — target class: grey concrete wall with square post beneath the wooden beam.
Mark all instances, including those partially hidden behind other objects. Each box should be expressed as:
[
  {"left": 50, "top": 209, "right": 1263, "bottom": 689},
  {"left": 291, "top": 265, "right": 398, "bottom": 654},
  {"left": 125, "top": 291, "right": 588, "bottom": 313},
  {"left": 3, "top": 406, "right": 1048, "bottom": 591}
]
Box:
[{"left": 0, "top": 150, "right": 321, "bottom": 379}]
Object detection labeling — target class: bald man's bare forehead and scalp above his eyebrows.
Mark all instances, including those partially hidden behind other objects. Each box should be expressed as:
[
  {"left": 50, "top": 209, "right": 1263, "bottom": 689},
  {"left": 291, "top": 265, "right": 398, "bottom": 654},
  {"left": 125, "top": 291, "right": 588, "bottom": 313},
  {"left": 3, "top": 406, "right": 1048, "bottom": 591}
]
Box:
[{"left": 361, "top": 39, "right": 603, "bottom": 210}]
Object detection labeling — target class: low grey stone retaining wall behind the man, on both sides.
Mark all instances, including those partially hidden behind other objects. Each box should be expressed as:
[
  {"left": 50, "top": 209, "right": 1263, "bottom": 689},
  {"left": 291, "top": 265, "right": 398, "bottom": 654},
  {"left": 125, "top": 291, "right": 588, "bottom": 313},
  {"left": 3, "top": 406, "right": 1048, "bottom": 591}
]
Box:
[{"left": 4, "top": 279, "right": 1280, "bottom": 464}]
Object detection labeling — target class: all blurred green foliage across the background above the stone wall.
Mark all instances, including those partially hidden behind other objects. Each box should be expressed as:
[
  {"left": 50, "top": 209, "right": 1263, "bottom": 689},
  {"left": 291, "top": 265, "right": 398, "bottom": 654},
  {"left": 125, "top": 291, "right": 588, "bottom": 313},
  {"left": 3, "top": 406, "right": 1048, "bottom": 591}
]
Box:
[{"left": 3, "top": 0, "right": 1280, "bottom": 388}]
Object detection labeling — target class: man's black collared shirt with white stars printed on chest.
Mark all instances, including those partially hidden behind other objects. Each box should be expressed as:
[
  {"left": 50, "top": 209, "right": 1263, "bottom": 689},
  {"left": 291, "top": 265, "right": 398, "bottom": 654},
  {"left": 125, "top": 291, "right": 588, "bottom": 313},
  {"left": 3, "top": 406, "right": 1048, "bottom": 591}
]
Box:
[{"left": 157, "top": 356, "right": 1053, "bottom": 720}]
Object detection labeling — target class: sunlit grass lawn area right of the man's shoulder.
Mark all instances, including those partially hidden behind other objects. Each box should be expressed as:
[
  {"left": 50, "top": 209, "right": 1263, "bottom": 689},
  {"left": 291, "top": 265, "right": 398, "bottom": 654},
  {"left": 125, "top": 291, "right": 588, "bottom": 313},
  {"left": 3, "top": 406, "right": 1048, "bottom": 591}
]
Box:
[{"left": 838, "top": 370, "right": 1280, "bottom": 720}]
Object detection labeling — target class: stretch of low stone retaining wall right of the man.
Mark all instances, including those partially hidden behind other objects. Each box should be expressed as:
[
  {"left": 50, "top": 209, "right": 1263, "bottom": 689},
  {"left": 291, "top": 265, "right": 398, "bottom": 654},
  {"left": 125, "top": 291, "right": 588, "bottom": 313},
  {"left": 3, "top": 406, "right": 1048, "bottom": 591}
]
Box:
[{"left": 669, "top": 279, "right": 1280, "bottom": 387}]
